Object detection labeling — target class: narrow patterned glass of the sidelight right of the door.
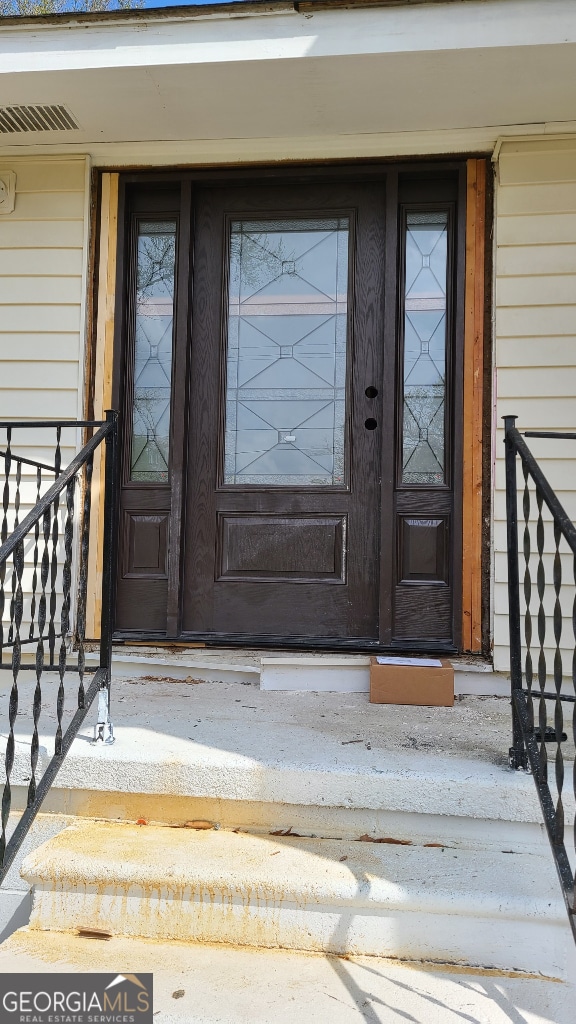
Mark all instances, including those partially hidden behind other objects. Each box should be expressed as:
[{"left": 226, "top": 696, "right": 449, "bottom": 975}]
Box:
[{"left": 402, "top": 212, "right": 448, "bottom": 485}]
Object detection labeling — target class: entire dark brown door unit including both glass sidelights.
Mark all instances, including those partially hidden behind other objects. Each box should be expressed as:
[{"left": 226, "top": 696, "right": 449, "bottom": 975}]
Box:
[{"left": 117, "top": 168, "right": 461, "bottom": 649}]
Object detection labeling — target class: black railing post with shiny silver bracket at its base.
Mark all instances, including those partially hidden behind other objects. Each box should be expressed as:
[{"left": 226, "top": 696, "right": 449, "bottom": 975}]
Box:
[{"left": 94, "top": 410, "right": 118, "bottom": 743}]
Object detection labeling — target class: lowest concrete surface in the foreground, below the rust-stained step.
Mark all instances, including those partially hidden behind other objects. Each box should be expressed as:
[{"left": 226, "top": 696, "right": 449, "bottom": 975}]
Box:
[{"left": 0, "top": 930, "right": 576, "bottom": 1024}]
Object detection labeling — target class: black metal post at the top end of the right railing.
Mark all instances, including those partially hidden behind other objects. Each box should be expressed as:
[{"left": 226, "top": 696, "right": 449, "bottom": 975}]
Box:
[{"left": 503, "top": 416, "right": 528, "bottom": 768}]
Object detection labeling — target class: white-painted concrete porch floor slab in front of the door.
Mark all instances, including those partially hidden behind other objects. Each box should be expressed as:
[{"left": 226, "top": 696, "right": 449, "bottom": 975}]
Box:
[{"left": 0, "top": 669, "right": 533, "bottom": 820}]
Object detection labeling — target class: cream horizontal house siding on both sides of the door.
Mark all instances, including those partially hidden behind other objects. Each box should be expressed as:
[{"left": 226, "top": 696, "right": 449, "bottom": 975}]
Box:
[{"left": 0, "top": 144, "right": 576, "bottom": 672}]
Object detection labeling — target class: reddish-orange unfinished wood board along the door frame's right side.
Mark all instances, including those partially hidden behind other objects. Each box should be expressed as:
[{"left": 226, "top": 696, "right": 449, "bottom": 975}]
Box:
[{"left": 462, "top": 159, "right": 486, "bottom": 651}]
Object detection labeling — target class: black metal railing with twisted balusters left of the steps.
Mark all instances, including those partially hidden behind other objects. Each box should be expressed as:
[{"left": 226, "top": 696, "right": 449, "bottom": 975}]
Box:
[{"left": 0, "top": 413, "right": 117, "bottom": 884}]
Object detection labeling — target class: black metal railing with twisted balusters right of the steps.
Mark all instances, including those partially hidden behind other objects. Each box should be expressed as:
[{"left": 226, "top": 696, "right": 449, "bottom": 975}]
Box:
[{"left": 504, "top": 416, "right": 576, "bottom": 939}]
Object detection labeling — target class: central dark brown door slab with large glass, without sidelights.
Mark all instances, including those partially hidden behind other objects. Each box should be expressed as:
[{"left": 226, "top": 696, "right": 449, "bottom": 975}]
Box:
[{"left": 182, "top": 185, "right": 384, "bottom": 637}]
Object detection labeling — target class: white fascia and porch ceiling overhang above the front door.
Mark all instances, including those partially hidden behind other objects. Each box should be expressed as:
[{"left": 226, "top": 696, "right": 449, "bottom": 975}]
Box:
[{"left": 0, "top": 0, "right": 576, "bottom": 147}]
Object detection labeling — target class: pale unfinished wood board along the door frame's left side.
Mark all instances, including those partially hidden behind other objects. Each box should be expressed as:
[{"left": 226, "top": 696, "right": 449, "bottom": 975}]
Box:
[{"left": 86, "top": 173, "right": 119, "bottom": 640}]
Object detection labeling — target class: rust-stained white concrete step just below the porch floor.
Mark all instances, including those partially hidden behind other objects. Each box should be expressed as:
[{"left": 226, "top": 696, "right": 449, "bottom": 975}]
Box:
[{"left": 22, "top": 822, "right": 569, "bottom": 978}]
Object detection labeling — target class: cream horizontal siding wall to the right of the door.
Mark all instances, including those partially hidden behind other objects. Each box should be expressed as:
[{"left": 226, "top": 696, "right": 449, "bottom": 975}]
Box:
[{"left": 493, "top": 138, "right": 576, "bottom": 671}]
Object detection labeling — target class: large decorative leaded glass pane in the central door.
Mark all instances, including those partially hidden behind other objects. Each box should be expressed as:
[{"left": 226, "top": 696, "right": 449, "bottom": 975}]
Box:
[{"left": 224, "top": 217, "right": 349, "bottom": 487}]
